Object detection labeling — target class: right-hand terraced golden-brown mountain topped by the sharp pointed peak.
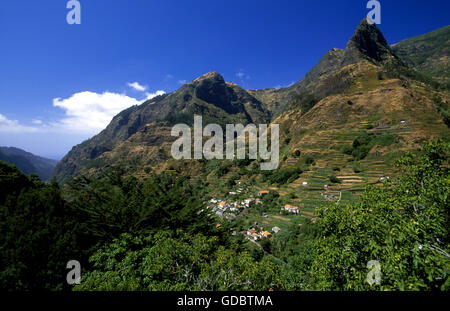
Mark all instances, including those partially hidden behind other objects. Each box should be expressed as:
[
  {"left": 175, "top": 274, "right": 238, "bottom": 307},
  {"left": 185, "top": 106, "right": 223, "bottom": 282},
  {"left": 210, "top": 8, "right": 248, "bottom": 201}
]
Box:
[{"left": 272, "top": 22, "right": 450, "bottom": 206}]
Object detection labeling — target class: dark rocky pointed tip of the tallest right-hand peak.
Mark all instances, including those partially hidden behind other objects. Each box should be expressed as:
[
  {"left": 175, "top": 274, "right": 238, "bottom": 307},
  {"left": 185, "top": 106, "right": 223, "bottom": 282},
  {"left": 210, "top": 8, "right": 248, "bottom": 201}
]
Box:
[{"left": 345, "top": 19, "right": 396, "bottom": 63}]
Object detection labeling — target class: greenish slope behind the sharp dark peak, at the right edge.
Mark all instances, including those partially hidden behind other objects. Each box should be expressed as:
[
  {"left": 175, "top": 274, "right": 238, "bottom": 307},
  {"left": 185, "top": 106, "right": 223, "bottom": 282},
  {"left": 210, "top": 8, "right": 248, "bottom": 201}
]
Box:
[{"left": 392, "top": 26, "right": 450, "bottom": 88}]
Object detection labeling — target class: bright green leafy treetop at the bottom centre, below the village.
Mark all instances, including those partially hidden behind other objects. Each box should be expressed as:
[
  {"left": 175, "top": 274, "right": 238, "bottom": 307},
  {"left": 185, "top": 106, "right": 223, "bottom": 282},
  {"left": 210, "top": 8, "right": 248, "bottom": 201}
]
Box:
[{"left": 76, "top": 232, "right": 281, "bottom": 290}]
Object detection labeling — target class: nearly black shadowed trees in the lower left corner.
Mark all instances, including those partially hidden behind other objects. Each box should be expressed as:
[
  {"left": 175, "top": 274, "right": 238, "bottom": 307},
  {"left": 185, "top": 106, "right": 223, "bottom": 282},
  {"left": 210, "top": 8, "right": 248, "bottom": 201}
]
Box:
[{"left": 0, "top": 161, "right": 85, "bottom": 290}]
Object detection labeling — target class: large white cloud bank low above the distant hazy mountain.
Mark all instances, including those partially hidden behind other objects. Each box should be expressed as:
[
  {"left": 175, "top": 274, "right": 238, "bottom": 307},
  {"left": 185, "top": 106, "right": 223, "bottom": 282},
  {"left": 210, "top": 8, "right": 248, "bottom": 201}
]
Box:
[{"left": 0, "top": 85, "right": 165, "bottom": 158}]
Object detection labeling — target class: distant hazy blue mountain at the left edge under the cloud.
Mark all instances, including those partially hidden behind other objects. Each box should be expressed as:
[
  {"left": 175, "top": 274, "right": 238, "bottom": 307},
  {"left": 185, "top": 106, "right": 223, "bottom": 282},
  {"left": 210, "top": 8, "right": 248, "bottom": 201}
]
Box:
[{"left": 0, "top": 147, "right": 58, "bottom": 181}]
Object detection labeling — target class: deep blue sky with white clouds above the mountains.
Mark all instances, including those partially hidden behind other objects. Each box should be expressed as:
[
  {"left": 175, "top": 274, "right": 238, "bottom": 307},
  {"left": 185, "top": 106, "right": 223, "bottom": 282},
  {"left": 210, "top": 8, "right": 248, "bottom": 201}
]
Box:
[{"left": 0, "top": 0, "right": 450, "bottom": 158}]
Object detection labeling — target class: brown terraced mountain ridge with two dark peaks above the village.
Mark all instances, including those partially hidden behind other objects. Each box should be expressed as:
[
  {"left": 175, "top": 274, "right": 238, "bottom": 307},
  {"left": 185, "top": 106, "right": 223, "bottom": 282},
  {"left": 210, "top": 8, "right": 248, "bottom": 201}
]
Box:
[{"left": 55, "top": 20, "right": 450, "bottom": 207}]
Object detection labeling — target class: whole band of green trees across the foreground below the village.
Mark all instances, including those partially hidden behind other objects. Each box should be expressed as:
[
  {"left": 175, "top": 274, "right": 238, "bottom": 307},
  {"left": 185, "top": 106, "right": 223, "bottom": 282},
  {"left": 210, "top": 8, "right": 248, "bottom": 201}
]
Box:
[{"left": 0, "top": 141, "right": 450, "bottom": 290}]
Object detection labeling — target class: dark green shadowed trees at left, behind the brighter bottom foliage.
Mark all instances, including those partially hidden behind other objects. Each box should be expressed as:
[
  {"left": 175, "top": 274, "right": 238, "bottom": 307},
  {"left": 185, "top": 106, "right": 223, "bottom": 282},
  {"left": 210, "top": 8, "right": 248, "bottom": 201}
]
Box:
[{"left": 0, "top": 162, "right": 218, "bottom": 290}]
